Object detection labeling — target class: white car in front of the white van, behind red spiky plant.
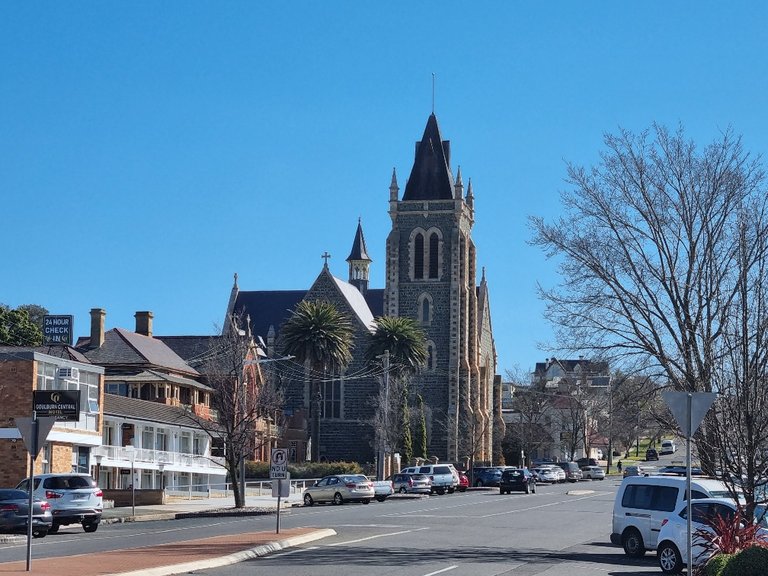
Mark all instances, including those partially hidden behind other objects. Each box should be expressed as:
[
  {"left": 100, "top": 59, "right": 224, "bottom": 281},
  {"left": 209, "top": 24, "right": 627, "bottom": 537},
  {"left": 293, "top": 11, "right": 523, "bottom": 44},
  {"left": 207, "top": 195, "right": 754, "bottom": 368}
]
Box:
[{"left": 657, "top": 498, "right": 768, "bottom": 574}]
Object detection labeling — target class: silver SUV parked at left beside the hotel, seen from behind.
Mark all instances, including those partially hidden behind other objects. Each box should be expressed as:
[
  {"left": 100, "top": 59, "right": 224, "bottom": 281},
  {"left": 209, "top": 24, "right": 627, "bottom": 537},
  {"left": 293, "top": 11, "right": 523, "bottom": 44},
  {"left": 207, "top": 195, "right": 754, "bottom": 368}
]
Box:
[{"left": 16, "top": 473, "right": 104, "bottom": 534}]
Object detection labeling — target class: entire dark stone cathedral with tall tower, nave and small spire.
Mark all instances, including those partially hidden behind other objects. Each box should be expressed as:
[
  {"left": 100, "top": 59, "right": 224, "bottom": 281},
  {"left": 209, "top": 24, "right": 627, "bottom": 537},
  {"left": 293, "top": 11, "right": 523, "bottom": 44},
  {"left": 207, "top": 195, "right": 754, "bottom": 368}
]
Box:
[{"left": 226, "top": 113, "right": 500, "bottom": 463}]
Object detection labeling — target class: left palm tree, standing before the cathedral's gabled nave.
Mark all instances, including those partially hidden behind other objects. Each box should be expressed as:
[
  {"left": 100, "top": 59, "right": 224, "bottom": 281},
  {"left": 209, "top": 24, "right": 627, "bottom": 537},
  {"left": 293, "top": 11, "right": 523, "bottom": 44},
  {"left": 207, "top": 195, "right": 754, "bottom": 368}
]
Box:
[{"left": 280, "top": 300, "right": 354, "bottom": 462}]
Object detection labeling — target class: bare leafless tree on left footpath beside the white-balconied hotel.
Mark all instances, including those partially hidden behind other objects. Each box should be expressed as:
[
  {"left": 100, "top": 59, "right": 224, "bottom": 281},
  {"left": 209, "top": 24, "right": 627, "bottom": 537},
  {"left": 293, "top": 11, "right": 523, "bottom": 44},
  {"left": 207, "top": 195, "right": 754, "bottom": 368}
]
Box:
[{"left": 190, "top": 316, "right": 283, "bottom": 508}]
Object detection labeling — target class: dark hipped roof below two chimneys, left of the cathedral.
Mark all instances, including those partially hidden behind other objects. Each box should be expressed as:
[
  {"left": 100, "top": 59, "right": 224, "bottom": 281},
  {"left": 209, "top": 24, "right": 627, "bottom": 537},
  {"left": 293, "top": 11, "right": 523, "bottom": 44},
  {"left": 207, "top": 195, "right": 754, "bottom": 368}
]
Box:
[{"left": 83, "top": 328, "right": 199, "bottom": 376}]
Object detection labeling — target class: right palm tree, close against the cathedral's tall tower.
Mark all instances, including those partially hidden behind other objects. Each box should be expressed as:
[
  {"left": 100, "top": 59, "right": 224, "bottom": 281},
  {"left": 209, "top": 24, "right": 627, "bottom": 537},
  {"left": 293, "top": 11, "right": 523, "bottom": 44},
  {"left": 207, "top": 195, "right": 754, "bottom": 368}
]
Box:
[{"left": 366, "top": 316, "right": 427, "bottom": 476}]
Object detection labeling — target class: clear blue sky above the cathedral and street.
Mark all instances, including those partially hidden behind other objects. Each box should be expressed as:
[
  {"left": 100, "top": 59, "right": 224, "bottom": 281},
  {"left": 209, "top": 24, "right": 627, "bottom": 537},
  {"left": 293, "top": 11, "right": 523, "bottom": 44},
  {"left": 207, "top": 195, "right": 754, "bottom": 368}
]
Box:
[{"left": 0, "top": 1, "right": 768, "bottom": 374}]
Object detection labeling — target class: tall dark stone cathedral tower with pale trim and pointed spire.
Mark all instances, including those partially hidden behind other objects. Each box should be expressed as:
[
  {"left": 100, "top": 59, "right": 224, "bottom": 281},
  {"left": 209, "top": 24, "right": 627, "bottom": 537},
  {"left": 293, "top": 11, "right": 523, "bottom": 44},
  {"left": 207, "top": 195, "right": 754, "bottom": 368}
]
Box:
[{"left": 384, "top": 114, "right": 496, "bottom": 461}]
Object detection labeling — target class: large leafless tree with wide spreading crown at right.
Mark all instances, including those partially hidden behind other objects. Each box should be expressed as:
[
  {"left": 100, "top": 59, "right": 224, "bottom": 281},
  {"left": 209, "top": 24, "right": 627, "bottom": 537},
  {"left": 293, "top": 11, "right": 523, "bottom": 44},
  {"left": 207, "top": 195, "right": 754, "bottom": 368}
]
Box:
[{"left": 531, "top": 126, "right": 768, "bottom": 502}]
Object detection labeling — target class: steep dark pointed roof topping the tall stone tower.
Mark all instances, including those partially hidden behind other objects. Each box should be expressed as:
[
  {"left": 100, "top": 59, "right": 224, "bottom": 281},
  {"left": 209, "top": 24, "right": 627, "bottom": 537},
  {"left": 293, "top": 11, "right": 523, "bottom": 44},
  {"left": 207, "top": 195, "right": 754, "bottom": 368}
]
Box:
[{"left": 403, "top": 113, "right": 453, "bottom": 200}]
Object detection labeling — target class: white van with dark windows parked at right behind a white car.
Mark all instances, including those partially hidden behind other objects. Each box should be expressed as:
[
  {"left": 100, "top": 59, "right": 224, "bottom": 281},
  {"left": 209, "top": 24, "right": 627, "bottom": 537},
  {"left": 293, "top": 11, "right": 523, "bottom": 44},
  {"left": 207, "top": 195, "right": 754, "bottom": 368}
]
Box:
[{"left": 611, "top": 476, "right": 731, "bottom": 558}]
